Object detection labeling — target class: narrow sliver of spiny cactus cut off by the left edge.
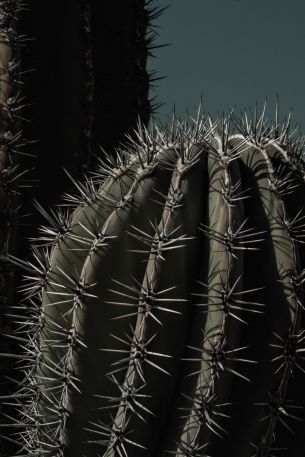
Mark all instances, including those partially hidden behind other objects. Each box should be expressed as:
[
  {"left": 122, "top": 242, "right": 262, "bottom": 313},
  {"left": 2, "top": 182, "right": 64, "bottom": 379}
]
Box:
[{"left": 0, "top": 0, "right": 30, "bottom": 455}]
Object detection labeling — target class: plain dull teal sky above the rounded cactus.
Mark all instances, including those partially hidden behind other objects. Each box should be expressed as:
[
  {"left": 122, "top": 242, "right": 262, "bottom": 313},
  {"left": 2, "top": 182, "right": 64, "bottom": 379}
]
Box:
[{"left": 148, "top": 0, "right": 305, "bottom": 134}]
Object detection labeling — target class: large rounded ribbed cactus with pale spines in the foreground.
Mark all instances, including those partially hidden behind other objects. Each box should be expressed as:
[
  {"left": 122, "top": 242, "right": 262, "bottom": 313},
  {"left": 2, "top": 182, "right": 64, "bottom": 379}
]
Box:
[{"left": 7, "top": 105, "right": 305, "bottom": 457}]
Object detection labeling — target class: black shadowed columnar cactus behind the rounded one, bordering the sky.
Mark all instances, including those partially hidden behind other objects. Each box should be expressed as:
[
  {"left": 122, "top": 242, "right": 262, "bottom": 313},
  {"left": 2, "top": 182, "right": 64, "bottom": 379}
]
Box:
[{"left": 20, "top": 0, "right": 162, "bottom": 207}]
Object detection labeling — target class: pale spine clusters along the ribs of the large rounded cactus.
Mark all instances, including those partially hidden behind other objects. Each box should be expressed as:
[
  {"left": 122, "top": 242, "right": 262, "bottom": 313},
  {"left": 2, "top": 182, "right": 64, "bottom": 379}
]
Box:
[{"left": 3, "top": 105, "right": 304, "bottom": 457}]
